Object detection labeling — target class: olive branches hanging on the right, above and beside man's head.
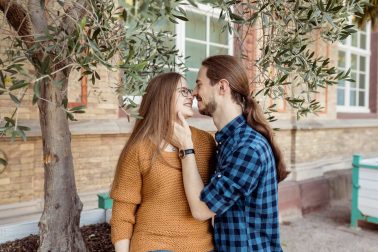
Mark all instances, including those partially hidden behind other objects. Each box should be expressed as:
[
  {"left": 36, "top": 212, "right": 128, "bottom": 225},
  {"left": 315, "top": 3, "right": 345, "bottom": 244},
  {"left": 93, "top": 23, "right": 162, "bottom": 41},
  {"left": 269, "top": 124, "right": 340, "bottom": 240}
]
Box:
[{"left": 205, "top": 0, "right": 364, "bottom": 121}]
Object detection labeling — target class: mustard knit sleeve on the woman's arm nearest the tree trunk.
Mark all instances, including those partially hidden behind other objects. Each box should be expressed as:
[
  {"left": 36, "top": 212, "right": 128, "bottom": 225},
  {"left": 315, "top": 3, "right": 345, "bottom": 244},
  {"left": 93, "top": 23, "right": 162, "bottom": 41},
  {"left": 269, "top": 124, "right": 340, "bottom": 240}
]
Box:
[{"left": 110, "top": 147, "right": 142, "bottom": 243}]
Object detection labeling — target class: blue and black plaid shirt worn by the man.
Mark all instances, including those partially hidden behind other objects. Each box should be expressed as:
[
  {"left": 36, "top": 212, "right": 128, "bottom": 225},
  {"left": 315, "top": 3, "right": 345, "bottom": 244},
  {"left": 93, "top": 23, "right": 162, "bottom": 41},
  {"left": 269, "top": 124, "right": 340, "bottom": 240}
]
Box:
[{"left": 201, "top": 115, "right": 282, "bottom": 252}]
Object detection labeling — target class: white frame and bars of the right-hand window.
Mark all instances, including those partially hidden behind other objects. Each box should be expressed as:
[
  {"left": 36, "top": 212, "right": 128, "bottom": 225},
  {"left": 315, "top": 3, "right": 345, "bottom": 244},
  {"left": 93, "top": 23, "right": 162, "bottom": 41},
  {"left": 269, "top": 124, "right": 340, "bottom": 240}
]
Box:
[{"left": 336, "top": 22, "right": 371, "bottom": 113}]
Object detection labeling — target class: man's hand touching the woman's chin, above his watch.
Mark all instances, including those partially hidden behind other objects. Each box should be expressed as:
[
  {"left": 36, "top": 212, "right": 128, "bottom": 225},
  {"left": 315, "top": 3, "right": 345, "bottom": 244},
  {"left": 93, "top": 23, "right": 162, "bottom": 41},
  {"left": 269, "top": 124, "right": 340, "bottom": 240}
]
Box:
[{"left": 171, "top": 112, "right": 193, "bottom": 150}]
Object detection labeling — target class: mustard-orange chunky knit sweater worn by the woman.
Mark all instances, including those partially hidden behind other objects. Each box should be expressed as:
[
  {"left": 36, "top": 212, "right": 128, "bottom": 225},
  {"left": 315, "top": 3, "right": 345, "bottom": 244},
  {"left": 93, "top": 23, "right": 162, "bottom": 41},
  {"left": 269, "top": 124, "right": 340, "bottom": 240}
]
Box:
[{"left": 110, "top": 128, "right": 215, "bottom": 252}]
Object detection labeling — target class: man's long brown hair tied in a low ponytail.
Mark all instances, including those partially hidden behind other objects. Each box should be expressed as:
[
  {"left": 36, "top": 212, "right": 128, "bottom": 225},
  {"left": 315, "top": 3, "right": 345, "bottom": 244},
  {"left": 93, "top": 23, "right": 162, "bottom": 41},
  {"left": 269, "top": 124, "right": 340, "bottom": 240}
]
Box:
[{"left": 202, "top": 55, "right": 289, "bottom": 182}]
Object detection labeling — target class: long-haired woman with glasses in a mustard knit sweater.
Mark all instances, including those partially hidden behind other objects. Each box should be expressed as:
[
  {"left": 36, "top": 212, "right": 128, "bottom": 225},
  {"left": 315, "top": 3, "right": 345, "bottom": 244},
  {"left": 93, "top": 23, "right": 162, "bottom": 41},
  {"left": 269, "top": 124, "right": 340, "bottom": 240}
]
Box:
[{"left": 110, "top": 72, "right": 215, "bottom": 252}]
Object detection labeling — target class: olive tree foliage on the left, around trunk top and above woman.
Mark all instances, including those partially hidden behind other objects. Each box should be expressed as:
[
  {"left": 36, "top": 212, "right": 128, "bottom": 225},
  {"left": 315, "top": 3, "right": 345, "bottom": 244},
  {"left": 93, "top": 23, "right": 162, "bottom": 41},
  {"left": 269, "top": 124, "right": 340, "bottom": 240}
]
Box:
[{"left": 0, "top": 0, "right": 184, "bottom": 138}]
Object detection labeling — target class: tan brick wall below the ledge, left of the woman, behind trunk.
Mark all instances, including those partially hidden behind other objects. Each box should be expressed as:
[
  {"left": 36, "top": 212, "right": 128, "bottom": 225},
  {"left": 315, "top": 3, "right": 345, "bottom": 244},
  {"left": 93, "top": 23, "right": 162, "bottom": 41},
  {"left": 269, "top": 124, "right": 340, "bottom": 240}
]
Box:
[{"left": 0, "top": 134, "right": 128, "bottom": 205}]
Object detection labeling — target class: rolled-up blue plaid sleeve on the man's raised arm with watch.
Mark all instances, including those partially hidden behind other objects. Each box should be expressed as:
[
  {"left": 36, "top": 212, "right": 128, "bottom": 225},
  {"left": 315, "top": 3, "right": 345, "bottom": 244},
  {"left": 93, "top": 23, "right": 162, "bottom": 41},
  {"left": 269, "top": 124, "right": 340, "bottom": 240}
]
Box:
[{"left": 201, "top": 146, "right": 262, "bottom": 215}]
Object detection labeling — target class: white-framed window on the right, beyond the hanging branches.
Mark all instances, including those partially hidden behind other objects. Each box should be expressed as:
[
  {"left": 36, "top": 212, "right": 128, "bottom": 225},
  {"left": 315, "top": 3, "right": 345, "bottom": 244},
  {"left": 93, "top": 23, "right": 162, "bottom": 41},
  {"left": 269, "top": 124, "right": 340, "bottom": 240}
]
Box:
[{"left": 337, "top": 23, "right": 370, "bottom": 113}]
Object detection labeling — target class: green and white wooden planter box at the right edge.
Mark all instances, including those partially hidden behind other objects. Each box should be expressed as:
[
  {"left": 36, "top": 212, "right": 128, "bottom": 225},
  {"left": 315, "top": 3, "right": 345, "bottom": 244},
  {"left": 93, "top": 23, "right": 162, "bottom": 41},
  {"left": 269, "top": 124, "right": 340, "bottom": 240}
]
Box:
[{"left": 350, "top": 155, "right": 378, "bottom": 228}]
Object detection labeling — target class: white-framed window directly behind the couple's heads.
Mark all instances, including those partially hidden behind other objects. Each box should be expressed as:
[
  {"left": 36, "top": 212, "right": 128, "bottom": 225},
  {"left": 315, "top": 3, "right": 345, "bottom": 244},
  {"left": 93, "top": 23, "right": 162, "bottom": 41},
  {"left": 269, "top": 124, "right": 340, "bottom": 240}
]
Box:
[{"left": 175, "top": 4, "right": 233, "bottom": 88}]
